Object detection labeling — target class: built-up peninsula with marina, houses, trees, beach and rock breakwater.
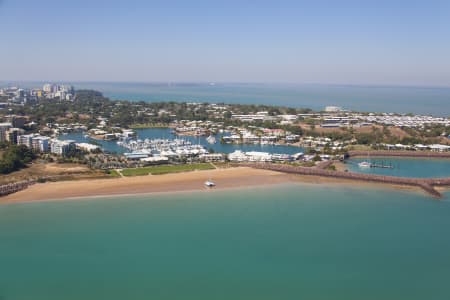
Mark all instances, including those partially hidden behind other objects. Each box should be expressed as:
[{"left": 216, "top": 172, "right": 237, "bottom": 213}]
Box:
[{"left": 0, "top": 84, "right": 450, "bottom": 202}]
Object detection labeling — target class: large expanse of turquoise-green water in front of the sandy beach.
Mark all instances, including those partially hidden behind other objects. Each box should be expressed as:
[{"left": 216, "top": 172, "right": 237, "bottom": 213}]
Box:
[{"left": 0, "top": 185, "right": 450, "bottom": 300}]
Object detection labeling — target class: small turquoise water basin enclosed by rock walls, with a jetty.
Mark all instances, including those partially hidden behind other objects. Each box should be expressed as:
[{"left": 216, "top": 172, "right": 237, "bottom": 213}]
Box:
[{"left": 346, "top": 157, "right": 450, "bottom": 178}]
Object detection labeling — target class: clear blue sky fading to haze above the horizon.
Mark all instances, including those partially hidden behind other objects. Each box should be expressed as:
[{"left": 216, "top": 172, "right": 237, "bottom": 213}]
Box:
[{"left": 0, "top": 0, "right": 450, "bottom": 86}]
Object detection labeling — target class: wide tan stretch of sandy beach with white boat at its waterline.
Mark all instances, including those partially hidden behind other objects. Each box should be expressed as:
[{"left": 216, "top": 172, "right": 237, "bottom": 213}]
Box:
[{"left": 0, "top": 167, "right": 291, "bottom": 203}]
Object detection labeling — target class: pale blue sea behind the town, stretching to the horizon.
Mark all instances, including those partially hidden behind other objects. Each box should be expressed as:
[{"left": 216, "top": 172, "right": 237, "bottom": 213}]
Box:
[{"left": 4, "top": 82, "right": 450, "bottom": 117}]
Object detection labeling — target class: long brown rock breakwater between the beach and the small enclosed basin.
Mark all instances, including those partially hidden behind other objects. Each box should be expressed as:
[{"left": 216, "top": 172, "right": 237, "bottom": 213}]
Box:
[{"left": 235, "top": 163, "right": 450, "bottom": 198}]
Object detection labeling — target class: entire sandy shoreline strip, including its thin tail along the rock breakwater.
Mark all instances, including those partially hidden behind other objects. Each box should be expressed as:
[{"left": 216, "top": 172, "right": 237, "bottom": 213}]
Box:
[{"left": 0, "top": 167, "right": 442, "bottom": 204}]
